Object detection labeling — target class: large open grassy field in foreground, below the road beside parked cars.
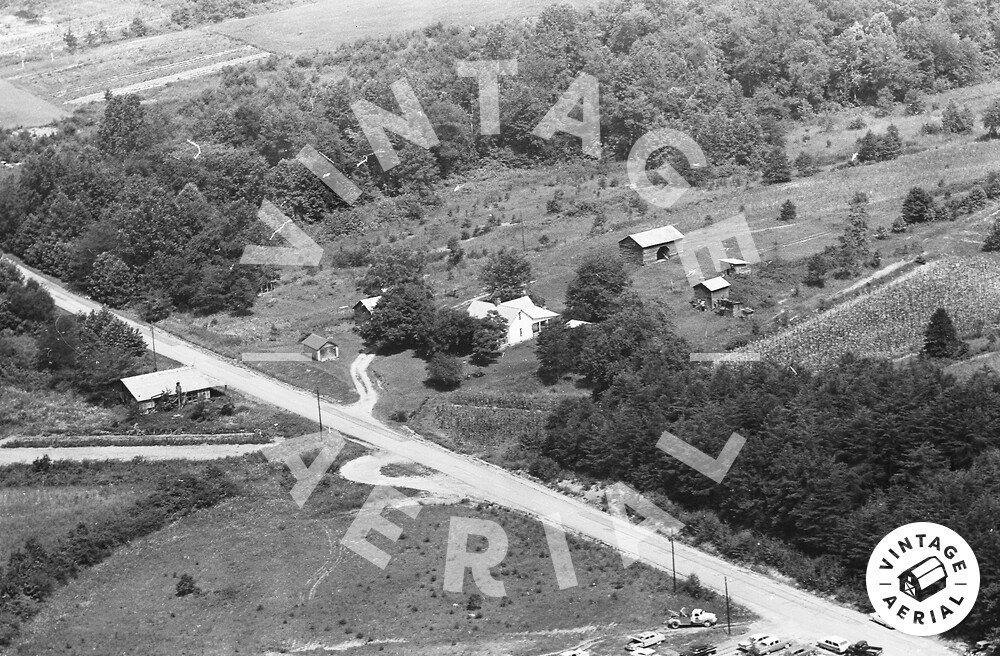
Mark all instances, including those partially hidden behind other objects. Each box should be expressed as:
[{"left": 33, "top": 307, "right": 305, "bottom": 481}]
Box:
[{"left": 10, "top": 454, "right": 750, "bottom": 656}]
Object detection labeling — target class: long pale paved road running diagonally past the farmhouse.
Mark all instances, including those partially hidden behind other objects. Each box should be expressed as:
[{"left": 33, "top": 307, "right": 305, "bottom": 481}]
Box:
[{"left": 7, "top": 260, "right": 954, "bottom": 656}]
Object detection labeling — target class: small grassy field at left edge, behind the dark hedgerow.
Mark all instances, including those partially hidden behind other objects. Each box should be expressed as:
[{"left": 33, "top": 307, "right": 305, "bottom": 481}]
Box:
[{"left": 0, "top": 486, "right": 139, "bottom": 564}]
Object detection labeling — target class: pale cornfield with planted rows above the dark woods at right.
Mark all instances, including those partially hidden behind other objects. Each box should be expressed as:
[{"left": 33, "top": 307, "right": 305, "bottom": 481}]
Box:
[{"left": 738, "top": 255, "right": 1000, "bottom": 370}]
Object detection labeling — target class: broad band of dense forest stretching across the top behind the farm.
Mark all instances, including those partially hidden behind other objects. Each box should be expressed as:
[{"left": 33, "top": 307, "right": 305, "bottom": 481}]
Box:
[{"left": 0, "top": 0, "right": 1000, "bottom": 319}]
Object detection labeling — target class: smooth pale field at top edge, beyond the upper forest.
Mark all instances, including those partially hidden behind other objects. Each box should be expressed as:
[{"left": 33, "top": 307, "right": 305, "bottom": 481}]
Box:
[{"left": 212, "top": 0, "right": 597, "bottom": 54}]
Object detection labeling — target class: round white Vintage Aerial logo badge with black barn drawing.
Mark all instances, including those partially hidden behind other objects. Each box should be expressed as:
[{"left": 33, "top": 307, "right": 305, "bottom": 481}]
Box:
[{"left": 866, "top": 522, "right": 979, "bottom": 636}]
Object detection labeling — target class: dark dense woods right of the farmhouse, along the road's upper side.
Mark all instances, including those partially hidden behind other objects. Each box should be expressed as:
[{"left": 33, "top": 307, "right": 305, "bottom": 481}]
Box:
[{"left": 525, "top": 261, "right": 1000, "bottom": 637}]
